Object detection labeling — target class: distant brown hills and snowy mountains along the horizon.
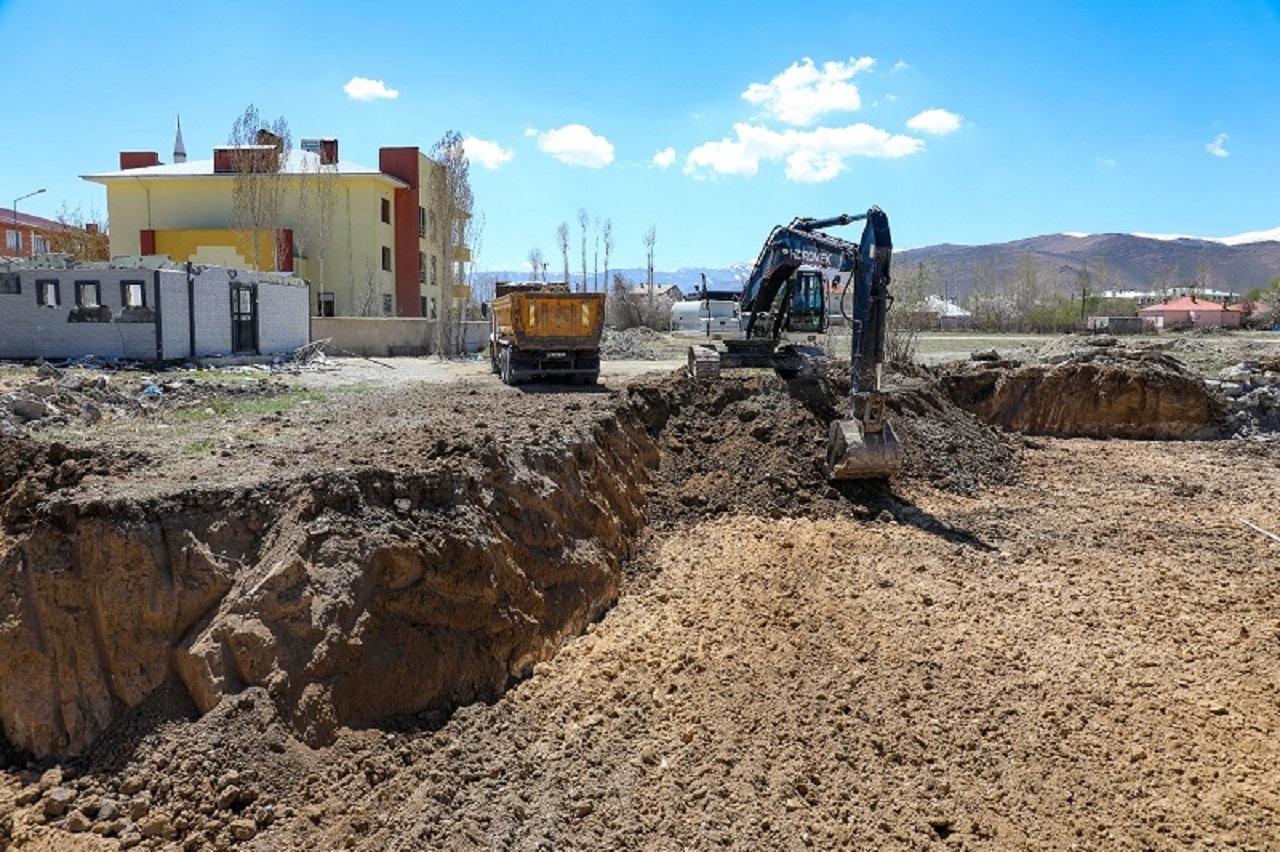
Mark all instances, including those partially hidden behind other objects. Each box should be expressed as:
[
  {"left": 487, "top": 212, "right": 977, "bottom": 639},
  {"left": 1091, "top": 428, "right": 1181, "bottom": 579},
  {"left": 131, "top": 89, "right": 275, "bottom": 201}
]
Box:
[{"left": 484, "top": 228, "right": 1280, "bottom": 299}]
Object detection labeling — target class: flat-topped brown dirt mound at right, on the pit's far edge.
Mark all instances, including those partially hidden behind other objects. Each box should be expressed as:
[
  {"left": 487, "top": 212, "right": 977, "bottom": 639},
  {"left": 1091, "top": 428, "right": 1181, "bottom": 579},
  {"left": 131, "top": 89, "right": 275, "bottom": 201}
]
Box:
[{"left": 941, "top": 348, "right": 1226, "bottom": 440}]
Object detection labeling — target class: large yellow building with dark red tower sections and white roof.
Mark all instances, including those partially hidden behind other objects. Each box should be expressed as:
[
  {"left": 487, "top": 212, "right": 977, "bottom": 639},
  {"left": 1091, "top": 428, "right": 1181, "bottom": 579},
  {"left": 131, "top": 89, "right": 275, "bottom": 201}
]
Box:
[{"left": 84, "top": 134, "right": 468, "bottom": 319}]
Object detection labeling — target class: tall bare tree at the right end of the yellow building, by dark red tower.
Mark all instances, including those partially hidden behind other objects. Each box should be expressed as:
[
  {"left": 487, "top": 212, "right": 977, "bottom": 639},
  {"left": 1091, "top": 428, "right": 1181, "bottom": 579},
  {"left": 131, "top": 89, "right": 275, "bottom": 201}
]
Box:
[{"left": 428, "top": 130, "right": 475, "bottom": 357}]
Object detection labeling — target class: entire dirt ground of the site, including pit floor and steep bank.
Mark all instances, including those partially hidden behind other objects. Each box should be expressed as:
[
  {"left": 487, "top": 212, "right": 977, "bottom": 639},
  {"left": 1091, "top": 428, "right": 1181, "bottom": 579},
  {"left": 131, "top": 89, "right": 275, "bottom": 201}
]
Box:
[{"left": 0, "top": 338, "right": 1280, "bottom": 849}]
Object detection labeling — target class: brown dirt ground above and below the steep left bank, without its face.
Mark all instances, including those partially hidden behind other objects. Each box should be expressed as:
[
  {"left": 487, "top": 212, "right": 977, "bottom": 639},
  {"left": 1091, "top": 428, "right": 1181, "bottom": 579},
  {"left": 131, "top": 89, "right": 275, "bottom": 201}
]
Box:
[{"left": 0, "top": 327, "right": 1280, "bottom": 849}]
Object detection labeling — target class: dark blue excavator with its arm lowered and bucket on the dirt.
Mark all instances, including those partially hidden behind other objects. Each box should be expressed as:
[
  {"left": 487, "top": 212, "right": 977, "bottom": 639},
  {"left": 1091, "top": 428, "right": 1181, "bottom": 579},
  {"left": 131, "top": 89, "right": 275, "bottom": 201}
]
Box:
[{"left": 689, "top": 207, "right": 902, "bottom": 480}]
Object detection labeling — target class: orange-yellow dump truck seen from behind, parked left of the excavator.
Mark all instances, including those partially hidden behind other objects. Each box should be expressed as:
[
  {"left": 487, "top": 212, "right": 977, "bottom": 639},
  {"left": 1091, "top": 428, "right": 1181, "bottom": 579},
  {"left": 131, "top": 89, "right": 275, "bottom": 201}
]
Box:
[{"left": 489, "top": 281, "right": 604, "bottom": 385}]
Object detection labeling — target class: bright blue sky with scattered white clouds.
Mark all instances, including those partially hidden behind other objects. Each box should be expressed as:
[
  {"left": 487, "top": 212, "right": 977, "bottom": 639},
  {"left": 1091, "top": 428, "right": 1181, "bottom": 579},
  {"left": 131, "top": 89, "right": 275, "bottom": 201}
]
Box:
[{"left": 0, "top": 0, "right": 1280, "bottom": 270}]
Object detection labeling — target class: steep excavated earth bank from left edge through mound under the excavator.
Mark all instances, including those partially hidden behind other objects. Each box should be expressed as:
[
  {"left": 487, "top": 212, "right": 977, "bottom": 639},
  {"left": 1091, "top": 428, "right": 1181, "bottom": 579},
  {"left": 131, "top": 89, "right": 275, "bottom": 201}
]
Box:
[{"left": 0, "top": 355, "right": 1223, "bottom": 757}]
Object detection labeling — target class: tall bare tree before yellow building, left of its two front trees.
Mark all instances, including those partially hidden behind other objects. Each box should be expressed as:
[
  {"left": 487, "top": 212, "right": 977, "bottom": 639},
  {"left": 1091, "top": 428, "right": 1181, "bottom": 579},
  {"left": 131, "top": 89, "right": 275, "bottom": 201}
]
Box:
[{"left": 228, "top": 104, "right": 292, "bottom": 270}]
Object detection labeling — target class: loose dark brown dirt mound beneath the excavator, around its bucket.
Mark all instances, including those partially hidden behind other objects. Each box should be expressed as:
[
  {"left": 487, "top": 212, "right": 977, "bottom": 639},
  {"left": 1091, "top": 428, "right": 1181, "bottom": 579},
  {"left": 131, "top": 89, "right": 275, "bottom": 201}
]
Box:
[{"left": 627, "top": 366, "right": 1016, "bottom": 522}]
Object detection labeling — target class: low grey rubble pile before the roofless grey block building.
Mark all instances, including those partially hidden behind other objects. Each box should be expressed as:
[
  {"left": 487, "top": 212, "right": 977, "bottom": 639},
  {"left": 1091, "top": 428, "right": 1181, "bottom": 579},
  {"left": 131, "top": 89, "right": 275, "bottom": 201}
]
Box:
[{"left": 0, "top": 363, "right": 289, "bottom": 435}]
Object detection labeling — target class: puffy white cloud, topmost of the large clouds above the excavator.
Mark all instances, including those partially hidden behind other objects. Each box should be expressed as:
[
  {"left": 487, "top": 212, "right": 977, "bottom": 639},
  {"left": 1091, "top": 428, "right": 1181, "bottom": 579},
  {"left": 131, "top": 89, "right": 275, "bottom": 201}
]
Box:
[{"left": 742, "top": 56, "right": 876, "bottom": 127}]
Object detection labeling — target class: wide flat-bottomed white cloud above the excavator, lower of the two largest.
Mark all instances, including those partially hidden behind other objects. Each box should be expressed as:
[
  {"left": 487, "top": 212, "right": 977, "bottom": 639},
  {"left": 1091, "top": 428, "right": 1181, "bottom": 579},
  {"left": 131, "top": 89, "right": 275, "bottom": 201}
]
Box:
[{"left": 685, "top": 123, "right": 924, "bottom": 183}]
